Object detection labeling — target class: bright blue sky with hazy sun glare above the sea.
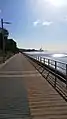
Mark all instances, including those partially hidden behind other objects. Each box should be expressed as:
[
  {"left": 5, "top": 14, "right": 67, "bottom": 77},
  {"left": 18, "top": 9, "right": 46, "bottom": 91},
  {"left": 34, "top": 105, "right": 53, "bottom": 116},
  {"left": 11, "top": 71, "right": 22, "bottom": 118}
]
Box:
[{"left": 0, "top": 0, "right": 67, "bottom": 52}]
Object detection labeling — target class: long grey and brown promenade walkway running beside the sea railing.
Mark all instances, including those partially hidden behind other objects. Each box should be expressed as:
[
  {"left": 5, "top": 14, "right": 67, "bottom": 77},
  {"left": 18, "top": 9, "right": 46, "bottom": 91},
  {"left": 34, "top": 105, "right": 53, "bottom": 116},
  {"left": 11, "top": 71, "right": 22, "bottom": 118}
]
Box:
[{"left": 0, "top": 54, "right": 67, "bottom": 119}]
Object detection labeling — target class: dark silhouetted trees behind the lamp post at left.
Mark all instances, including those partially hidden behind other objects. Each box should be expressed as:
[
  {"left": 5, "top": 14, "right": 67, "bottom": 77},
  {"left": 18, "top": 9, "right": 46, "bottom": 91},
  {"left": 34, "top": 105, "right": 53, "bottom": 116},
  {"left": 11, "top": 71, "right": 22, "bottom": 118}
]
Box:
[{"left": 0, "top": 28, "right": 18, "bottom": 53}]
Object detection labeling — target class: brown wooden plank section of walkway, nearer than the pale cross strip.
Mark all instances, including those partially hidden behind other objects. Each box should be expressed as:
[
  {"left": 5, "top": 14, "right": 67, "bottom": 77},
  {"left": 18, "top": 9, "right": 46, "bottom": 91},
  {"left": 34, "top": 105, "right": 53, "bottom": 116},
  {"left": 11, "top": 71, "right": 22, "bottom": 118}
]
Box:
[{"left": 25, "top": 69, "right": 67, "bottom": 119}]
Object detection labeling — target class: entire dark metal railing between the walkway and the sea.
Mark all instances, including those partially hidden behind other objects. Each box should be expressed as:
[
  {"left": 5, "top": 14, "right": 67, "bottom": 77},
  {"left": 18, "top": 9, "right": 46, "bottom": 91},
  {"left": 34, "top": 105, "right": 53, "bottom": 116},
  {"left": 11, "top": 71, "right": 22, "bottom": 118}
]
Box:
[{"left": 24, "top": 53, "right": 67, "bottom": 101}]
